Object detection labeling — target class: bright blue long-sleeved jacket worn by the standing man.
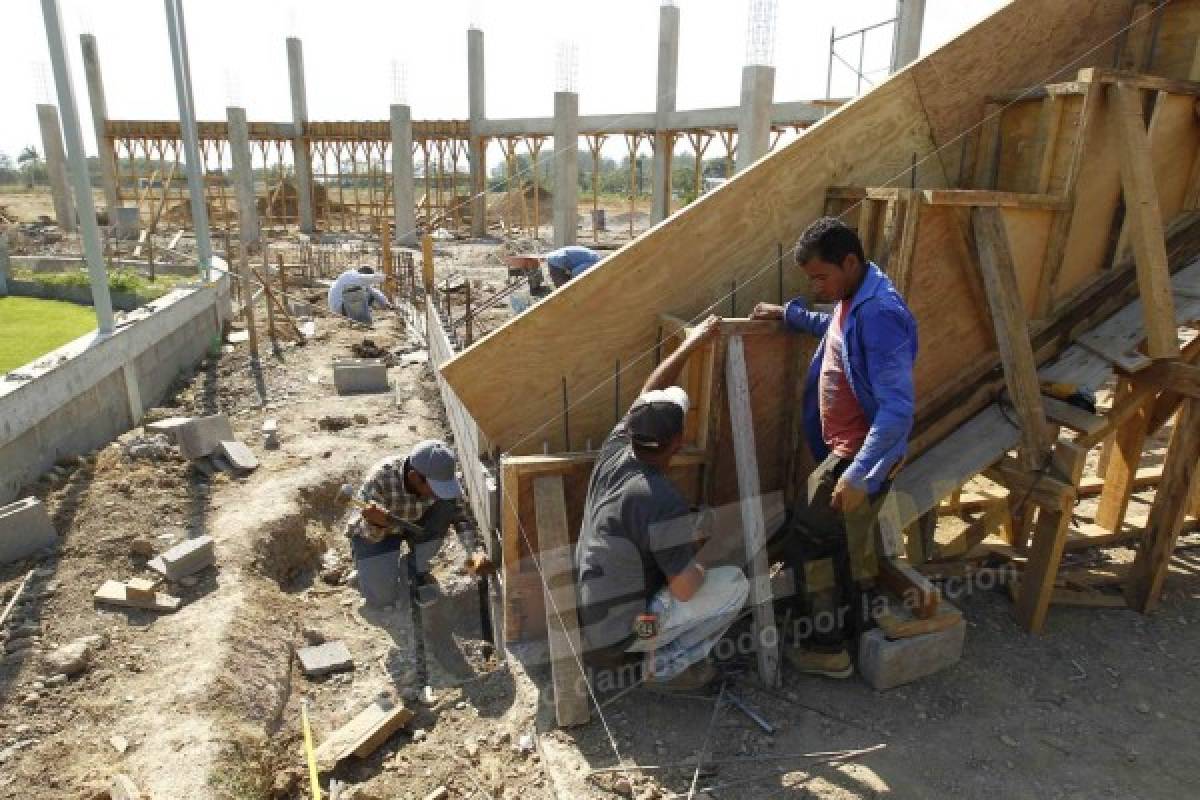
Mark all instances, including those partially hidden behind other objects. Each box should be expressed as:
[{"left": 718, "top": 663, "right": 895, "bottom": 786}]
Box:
[{"left": 784, "top": 264, "right": 917, "bottom": 494}]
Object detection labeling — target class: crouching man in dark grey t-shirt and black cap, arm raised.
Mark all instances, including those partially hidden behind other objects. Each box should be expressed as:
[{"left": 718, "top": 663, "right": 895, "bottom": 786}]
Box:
[{"left": 575, "top": 317, "right": 749, "bottom": 691}]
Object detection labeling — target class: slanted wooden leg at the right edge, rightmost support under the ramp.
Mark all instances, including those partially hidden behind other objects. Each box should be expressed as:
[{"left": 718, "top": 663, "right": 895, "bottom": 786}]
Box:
[{"left": 1124, "top": 398, "right": 1200, "bottom": 614}]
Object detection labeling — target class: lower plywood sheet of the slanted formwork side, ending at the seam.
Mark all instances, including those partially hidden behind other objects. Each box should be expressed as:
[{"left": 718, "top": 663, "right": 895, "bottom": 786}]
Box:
[{"left": 443, "top": 76, "right": 944, "bottom": 453}]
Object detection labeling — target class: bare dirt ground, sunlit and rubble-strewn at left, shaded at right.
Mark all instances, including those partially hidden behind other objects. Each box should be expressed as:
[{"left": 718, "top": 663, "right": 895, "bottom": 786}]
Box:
[{"left": 0, "top": 235, "right": 1200, "bottom": 800}]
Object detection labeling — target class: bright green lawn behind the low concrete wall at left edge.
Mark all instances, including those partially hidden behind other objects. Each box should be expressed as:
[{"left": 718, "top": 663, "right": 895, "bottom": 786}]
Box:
[{"left": 0, "top": 297, "right": 96, "bottom": 373}]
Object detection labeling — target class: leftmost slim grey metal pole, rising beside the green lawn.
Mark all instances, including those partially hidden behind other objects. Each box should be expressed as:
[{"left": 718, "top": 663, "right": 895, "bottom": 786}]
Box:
[{"left": 42, "top": 0, "right": 113, "bottom": 336}]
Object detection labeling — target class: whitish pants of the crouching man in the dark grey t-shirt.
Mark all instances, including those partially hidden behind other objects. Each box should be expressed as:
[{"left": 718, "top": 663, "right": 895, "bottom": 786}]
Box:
[{"left": 629, "top": 566, "right": 750, "bottom": 680}]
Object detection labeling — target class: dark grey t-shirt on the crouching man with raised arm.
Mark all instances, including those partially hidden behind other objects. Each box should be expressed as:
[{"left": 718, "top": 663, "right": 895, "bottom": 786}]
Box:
[{"left": 575, "top": 420, "right": 696, "bottom": 649}]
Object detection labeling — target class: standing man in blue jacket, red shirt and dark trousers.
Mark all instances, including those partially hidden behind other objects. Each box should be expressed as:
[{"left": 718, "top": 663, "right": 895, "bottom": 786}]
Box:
[{"left": 752, "top": 217, "right": 917, "bottom": 678}]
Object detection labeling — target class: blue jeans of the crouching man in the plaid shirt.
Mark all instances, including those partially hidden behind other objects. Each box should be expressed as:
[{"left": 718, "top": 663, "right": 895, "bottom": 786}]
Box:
[{"left": 350, "top": 500, "right": 458, "bottom": 608}]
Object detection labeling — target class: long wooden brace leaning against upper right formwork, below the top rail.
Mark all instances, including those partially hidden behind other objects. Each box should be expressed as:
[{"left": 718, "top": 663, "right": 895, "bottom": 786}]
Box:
[{"left": 1109, "top": 83, "right": 1180, "bottom": 359}]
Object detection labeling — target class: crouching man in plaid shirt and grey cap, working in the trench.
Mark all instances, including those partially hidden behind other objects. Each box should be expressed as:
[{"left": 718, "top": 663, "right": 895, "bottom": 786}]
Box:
[{"left": 346, "top": 439, "right": 462, "bottom": 607}]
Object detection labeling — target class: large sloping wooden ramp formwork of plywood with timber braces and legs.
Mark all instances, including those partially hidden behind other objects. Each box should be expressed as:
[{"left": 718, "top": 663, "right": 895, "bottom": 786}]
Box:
[{"left": 440, "top": 0, "right": 1200, "bottom": 681}]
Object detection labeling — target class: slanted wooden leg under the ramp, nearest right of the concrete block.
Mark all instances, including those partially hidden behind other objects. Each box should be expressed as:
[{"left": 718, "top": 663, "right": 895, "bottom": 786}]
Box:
[{"left": 1016, "top": 441, "right": 1087, "bottom": 633}]
